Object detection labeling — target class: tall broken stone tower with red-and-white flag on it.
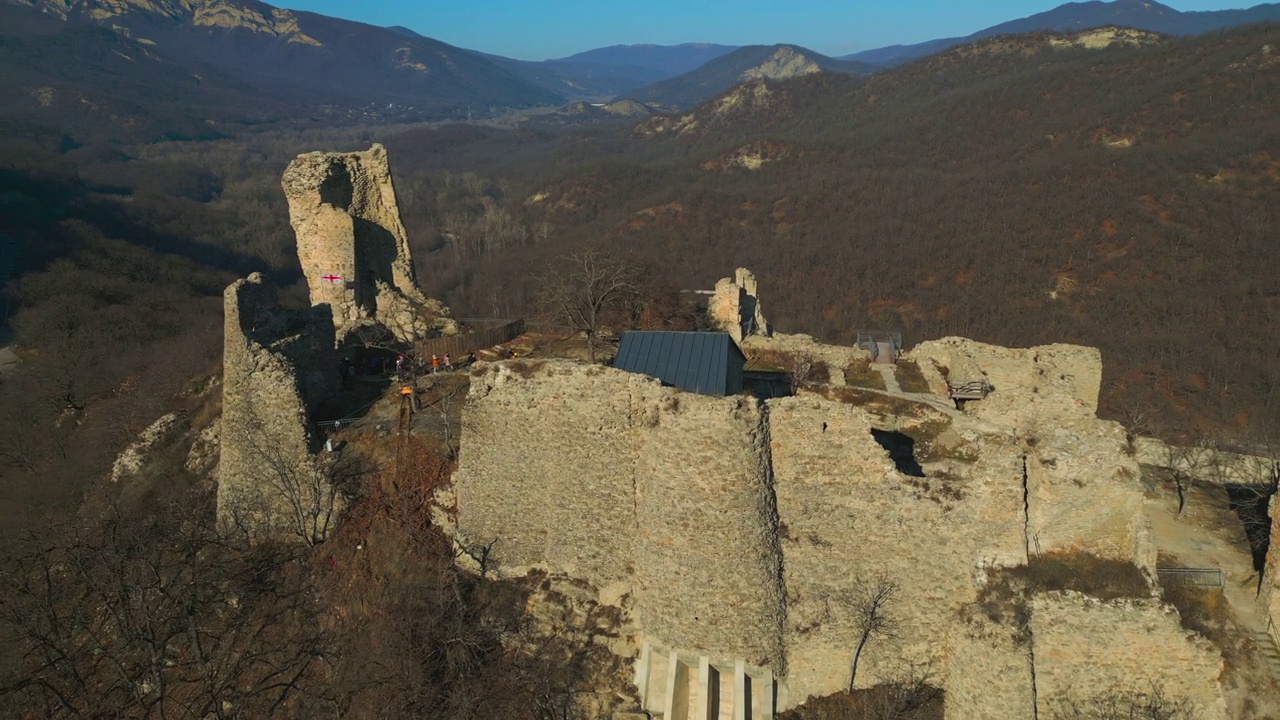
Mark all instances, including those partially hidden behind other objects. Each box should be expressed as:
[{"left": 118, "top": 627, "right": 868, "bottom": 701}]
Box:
[{"left": 282, "top": 145, "right": 457, "bottom": 342}]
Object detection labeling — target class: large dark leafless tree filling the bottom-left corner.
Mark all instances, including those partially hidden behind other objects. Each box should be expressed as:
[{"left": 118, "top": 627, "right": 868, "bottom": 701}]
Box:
[{"left": 0, "top": 505, "right": 330, "bottom": 717}]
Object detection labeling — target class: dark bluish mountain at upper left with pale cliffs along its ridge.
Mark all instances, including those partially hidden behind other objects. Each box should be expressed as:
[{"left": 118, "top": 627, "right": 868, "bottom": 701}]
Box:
[{"left": 6, "top": 0, "right": 563, "bottom": 114}]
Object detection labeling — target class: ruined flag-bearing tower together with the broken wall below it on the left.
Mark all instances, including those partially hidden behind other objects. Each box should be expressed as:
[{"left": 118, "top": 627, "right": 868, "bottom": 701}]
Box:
[{"left": 218, "top": 145, "right": 457, "bottom": 542}]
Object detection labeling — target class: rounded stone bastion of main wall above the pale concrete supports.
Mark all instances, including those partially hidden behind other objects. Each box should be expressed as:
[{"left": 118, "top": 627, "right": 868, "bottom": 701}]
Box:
[{"left": 635, "top": 391, "right": 783, "bottom": 673}]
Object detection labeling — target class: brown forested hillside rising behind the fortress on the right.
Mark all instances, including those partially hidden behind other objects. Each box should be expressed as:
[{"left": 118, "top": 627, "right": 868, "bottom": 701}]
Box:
[{"left": 389, "top": 26, "right": 1280, "bottom": 432}]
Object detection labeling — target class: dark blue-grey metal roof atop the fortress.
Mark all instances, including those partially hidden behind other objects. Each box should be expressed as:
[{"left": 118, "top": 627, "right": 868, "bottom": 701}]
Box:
[{"left": 613, "top": 332, "right": 746, "bottom": 396}]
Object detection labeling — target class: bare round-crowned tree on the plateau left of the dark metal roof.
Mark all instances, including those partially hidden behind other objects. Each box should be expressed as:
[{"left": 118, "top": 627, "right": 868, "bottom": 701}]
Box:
[{"left": 534, "top": 249, "right": 636, "bottom": 363}]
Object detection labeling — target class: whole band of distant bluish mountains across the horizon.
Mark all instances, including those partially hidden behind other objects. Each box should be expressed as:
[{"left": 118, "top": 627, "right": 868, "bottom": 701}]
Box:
[{"left": 0, "top": 0, "right": 1280, "bottom": 122}]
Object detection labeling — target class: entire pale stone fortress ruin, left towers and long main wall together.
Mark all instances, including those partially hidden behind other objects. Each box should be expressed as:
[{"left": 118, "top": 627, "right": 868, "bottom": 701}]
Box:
[{"left": 218, "top": 146, "right": 1280, "bottom": 720}]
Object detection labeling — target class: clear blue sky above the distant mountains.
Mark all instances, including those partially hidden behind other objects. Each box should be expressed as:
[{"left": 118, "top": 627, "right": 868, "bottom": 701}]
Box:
[{"left": 273, "top": 0, "right": 1256, "bottom": 60}]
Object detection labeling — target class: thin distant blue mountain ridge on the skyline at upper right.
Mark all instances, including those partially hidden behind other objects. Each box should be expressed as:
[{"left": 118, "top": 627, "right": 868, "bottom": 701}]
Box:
[{"left": 840, "top": 0, "right": 1280, "bottom": 67}]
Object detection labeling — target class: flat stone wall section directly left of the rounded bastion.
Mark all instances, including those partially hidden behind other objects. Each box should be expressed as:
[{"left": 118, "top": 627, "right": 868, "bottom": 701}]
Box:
[{"left": 453, "top": 361, "right": 650, "bottom": 588}]
